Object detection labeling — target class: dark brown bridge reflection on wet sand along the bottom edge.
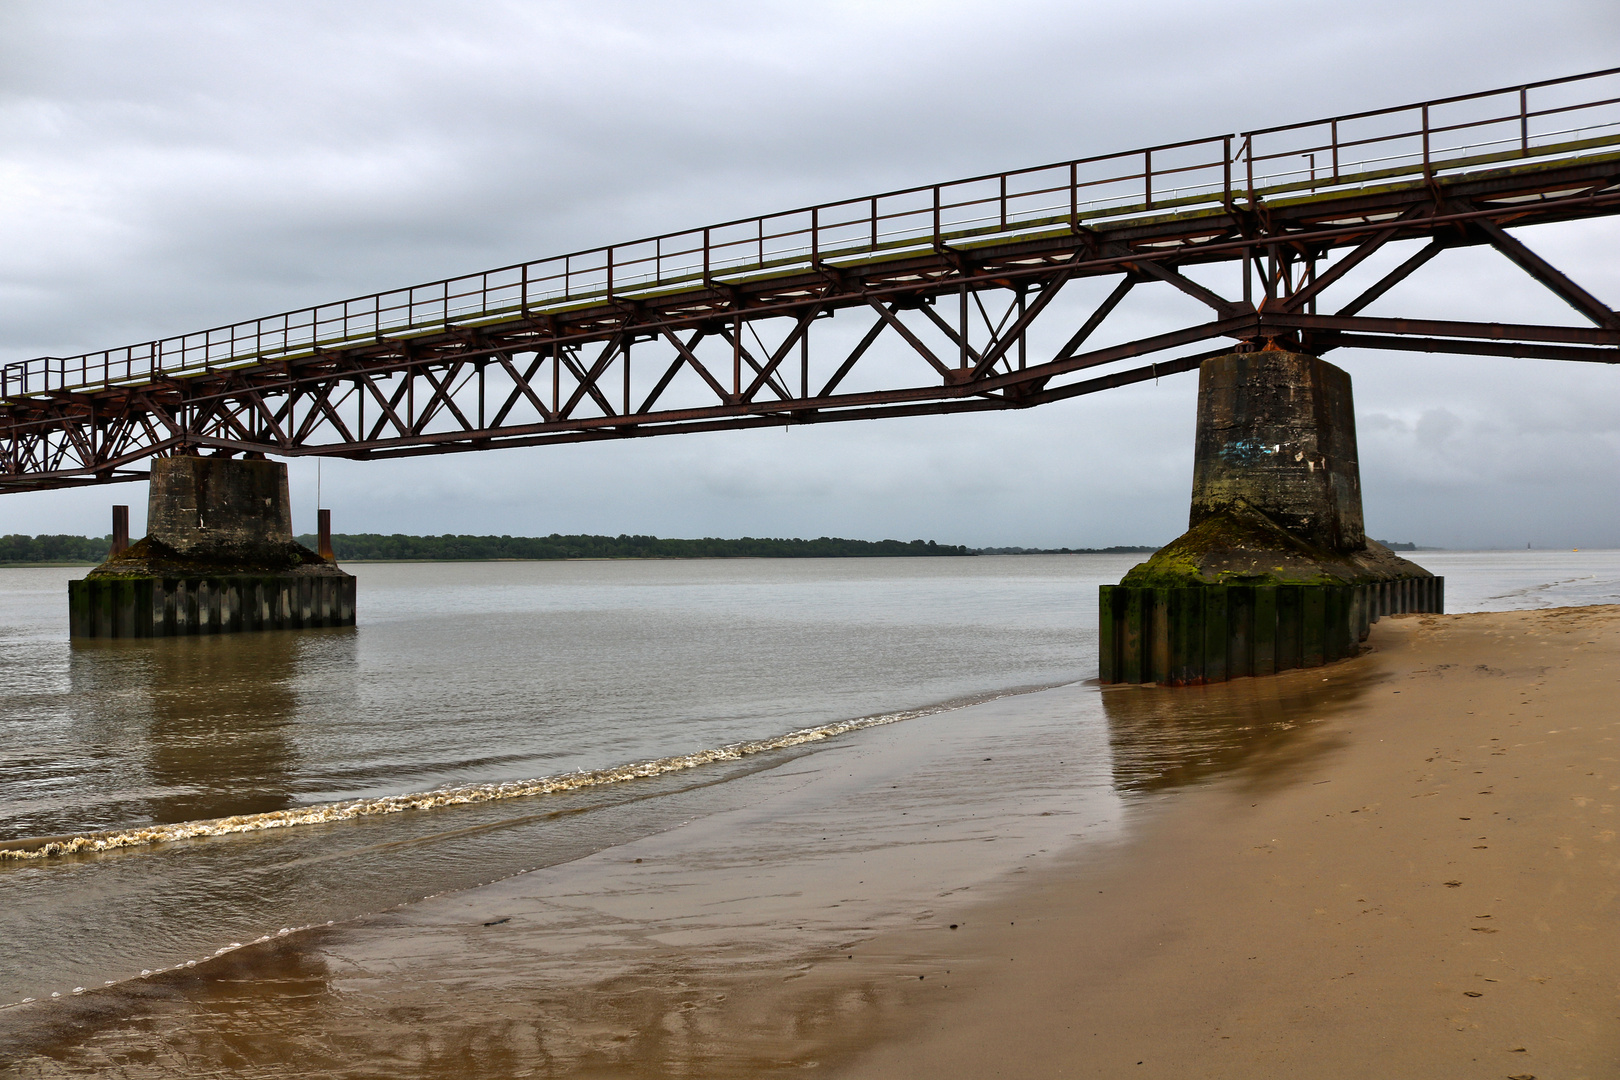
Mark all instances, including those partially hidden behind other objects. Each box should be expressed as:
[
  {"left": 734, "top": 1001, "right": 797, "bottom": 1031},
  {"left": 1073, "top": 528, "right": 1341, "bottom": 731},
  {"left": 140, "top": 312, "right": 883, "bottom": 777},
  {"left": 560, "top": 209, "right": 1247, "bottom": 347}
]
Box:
[{"left": 0, "top": 931, "right": 915, "bottom": 1080}]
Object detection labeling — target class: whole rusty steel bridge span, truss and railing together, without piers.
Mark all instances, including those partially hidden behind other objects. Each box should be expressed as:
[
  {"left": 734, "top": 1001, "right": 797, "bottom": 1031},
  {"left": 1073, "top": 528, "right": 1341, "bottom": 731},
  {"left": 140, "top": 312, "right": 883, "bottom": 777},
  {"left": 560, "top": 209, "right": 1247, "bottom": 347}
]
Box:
[{"left": 0, "top": 68, "right": 1620, "bottom": 491}]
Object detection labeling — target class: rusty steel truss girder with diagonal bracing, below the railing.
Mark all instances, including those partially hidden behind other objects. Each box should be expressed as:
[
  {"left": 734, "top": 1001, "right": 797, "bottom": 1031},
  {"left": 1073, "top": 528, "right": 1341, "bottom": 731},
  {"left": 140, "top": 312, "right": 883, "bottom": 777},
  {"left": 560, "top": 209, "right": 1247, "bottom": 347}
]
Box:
[{"left": 0, "top": 162, "right": 1620, "bottom": 492}]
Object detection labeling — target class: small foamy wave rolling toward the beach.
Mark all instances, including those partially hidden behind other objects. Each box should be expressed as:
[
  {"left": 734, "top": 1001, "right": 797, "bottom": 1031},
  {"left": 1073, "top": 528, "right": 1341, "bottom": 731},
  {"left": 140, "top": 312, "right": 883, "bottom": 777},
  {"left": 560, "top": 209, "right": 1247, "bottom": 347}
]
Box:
[{"left": 0, "top": 705, "right": 959, "bottom": 860}]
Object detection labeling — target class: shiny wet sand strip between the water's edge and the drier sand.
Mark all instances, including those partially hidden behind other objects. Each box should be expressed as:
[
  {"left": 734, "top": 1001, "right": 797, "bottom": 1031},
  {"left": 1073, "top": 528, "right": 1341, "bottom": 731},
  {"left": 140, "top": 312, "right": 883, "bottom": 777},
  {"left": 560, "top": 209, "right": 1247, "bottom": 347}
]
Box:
[{"left": 0, "top": 664, "right": 1393, "bottom": 1078}]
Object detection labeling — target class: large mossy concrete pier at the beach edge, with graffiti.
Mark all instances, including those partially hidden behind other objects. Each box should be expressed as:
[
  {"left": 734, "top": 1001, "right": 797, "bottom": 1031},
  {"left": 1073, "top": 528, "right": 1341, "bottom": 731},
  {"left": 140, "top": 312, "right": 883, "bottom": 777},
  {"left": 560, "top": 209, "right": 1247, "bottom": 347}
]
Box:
[{"left": 1100, "top": 348, "right": 1445, "bottom": 685}]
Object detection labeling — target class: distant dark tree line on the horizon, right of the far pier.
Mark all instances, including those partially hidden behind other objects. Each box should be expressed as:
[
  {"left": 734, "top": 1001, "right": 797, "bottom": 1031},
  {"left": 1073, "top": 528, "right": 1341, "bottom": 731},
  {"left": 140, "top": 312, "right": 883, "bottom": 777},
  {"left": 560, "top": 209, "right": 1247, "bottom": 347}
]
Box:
[{"left": 298, "top": 533, "right": 974, "bottom": 562}]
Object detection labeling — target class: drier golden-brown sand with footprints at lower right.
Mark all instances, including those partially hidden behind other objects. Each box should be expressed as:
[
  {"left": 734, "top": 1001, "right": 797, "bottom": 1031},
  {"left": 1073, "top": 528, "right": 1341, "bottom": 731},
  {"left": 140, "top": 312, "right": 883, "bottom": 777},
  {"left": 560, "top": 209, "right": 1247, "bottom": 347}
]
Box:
[{"left": 839, "top": 607, "right": 1620, "bottom": 1080}]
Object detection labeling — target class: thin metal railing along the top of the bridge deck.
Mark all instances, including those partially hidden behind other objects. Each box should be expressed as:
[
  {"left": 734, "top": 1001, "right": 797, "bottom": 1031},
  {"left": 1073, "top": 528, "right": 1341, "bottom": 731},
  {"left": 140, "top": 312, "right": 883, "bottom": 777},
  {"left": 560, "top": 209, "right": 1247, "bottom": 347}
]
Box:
[{"left": 0, "top": 68, "right": 1620, "bottom": 398}]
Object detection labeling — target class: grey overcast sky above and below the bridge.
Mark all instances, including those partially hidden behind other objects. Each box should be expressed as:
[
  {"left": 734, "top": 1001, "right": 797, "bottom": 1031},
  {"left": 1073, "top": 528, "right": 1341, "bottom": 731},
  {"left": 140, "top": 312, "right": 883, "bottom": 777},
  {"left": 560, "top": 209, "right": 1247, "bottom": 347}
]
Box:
[{"left": 0, "top": 0, "right": 1620, "bottom": 547}]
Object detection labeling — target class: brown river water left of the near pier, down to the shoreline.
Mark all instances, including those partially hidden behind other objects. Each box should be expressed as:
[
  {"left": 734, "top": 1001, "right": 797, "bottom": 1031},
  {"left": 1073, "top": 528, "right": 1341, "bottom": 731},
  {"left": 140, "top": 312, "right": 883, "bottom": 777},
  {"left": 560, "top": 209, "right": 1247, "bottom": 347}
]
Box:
[{"left": 0, "top": 559, "right": 1129, "bottom": 1002}]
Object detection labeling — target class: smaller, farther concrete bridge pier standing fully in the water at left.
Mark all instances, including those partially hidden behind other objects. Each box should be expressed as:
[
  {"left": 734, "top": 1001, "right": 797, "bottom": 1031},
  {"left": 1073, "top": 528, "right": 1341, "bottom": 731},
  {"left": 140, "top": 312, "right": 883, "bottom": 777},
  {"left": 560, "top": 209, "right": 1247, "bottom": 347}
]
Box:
[{"left": 68, "top": 455, "right": 355, "bottom": 638}]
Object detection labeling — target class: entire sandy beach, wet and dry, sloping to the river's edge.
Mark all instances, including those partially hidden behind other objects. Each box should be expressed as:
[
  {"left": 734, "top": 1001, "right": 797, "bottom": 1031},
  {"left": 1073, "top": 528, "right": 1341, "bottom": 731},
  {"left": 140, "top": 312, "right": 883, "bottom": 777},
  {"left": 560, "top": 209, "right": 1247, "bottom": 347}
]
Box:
[{"left": 0, "top": 607, "right": 1620, "bottom": 1080}]
